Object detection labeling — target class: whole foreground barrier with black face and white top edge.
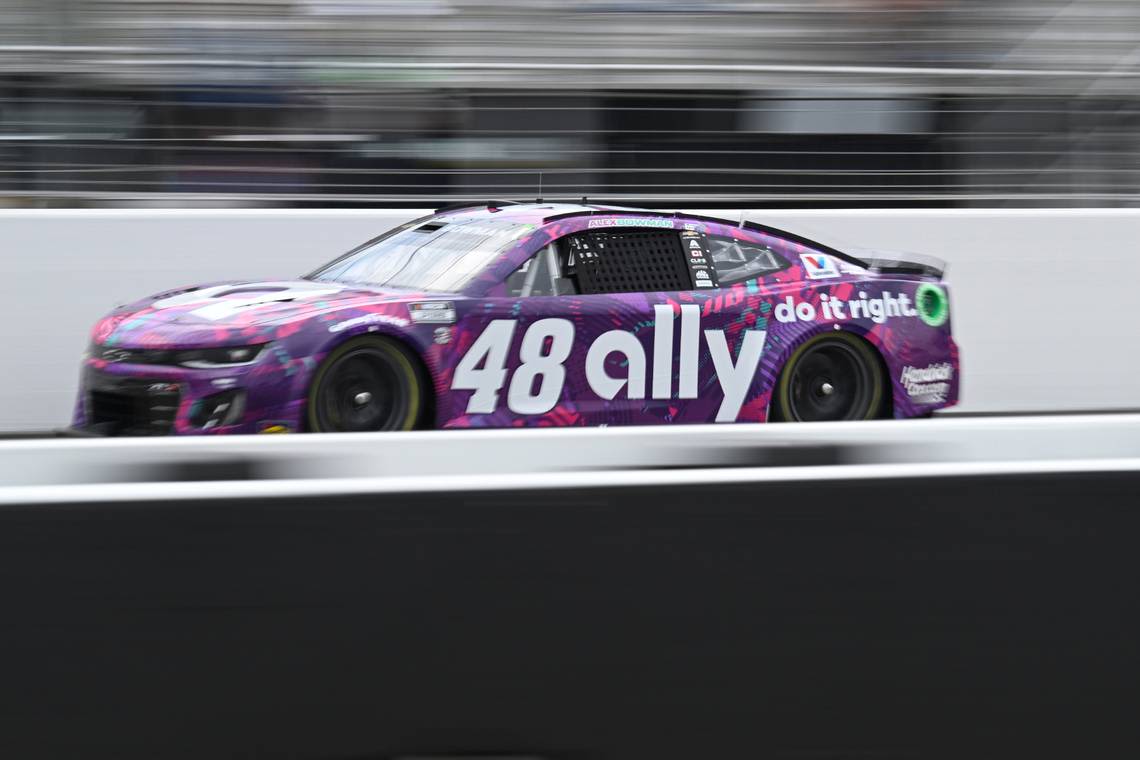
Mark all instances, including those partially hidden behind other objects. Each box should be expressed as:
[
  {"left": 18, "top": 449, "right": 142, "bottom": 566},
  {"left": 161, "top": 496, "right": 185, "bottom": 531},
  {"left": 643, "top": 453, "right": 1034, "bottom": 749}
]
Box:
[{"left": 0, "top": 418, "right": 1140, "bottom": 759}]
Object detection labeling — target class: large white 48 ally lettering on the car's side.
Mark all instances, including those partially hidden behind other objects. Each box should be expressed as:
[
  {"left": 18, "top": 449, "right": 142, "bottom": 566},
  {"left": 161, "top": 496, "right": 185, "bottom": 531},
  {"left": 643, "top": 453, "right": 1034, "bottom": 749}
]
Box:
[{"left": 451, "top": 304, "right": 767, "bottom": 423}]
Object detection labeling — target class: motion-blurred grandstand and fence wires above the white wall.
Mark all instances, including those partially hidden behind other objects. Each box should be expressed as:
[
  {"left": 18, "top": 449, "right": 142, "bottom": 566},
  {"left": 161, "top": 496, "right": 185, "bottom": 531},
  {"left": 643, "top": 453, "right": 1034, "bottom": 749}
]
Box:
[{"left": 0, "top": 0, "right": 1140, "bottom": 207}]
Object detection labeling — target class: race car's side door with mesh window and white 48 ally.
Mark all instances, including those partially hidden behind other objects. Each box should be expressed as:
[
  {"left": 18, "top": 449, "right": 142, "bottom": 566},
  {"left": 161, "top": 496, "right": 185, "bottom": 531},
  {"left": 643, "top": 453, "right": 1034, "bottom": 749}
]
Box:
[{"left": 451, "top": 228, "right": 764, "bottom": 426}]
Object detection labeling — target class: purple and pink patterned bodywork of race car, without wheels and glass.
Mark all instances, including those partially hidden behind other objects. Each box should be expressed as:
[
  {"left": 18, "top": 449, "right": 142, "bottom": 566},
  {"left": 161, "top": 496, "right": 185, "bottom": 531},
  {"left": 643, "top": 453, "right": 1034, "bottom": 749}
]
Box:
[{"left": 73, "top": 204, "right": 959, "bottom": 434}]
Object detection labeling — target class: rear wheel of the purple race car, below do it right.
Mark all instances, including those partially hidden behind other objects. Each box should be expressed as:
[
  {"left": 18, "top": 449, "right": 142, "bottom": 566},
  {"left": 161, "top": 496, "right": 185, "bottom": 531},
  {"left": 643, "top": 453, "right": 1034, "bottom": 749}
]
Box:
[{"left": 772, "top": 333, "right": 887, "bottom": 422}]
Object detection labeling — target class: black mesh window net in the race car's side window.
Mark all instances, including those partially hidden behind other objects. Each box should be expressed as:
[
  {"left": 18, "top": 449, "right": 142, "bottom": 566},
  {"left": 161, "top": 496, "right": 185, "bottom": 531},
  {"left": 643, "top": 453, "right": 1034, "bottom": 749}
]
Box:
[{"left": 559, "top": 229, "right": 693, "bottom": 295}]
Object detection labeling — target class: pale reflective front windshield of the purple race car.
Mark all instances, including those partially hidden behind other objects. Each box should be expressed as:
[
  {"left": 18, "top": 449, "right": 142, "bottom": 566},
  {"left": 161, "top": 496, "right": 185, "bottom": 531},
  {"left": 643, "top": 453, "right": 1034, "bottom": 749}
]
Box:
[{"left": 310, "top": 219, "right": 535, "bottom": 293}]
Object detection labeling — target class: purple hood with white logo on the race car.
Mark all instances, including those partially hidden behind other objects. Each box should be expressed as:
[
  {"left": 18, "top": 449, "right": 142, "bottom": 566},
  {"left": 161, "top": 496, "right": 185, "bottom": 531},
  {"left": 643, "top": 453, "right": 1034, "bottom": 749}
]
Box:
[{"left": 92, "top": 280, "right": 444, "bottom": 348}]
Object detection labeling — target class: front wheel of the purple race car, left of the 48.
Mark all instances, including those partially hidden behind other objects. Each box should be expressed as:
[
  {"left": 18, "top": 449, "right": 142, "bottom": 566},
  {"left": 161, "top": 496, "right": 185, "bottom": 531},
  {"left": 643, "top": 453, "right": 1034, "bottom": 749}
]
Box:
[{"left": 308, "top": 336, "right": 426, "bottom": 433}]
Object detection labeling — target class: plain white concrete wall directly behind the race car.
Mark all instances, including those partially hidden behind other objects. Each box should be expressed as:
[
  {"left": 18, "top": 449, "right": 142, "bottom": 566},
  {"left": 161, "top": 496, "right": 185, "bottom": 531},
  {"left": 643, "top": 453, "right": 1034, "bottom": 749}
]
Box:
[{"left": 0, "top": 210, "right": 1140, "bottom": 432}]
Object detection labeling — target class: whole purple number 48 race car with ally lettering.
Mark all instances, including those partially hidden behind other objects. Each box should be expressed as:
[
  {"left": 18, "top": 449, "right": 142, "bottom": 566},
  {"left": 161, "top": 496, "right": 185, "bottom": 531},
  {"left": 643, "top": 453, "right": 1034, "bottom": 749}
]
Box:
[{"left": 73, "top": 202, "right": 959, "bottom": 435}]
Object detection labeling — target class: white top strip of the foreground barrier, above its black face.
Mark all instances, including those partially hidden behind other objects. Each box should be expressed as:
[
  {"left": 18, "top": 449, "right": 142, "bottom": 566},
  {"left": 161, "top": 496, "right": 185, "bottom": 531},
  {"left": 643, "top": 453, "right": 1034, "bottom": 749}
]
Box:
[{"left": 0, "top": 414, "right": 1140, "bottom": 494}]
